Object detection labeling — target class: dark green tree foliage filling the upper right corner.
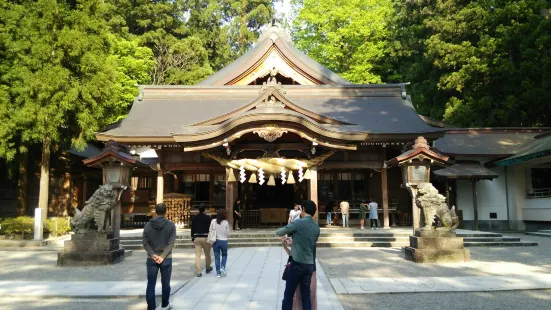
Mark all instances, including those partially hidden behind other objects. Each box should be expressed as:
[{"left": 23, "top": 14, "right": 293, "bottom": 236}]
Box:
[{"left": 386, "top": 0, "right": 551, "bottom": 126}]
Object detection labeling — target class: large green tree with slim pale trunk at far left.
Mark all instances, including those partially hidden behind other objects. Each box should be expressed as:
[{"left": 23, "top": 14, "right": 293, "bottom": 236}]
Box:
[{"left": 0, "top": 0, "right": 151, "bottom": 217}]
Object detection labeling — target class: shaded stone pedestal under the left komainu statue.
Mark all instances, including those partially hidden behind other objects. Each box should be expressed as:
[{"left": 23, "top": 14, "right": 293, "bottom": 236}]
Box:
[{"left": 57, "top": 233, "right": 124, "bottom": 266}]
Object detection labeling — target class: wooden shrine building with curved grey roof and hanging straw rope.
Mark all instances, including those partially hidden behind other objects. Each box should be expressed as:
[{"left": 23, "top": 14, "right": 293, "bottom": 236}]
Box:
[{"left": 91, "top": 25, "right": 551, "bottom": 229}]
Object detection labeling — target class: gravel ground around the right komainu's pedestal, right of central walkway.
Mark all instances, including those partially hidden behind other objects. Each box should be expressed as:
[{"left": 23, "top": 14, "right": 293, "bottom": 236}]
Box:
[{"left": 318, "top": 234, "right": 551, "bottom": 278}]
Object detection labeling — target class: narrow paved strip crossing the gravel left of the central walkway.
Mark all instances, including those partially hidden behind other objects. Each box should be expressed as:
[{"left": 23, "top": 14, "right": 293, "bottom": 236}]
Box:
[{"left": 0, "top": 280, "right": 186, "bottom": 298}]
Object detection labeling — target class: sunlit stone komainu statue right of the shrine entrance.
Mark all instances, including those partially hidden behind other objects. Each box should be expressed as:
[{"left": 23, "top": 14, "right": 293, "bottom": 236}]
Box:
[{"left": 415, "top": 183, "right": 459, "bottom": 231}]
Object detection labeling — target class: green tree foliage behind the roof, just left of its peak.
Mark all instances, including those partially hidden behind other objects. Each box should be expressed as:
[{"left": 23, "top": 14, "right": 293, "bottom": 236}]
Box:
[{"left": 110, "top": 0, "right": 213, "bottom": 84}]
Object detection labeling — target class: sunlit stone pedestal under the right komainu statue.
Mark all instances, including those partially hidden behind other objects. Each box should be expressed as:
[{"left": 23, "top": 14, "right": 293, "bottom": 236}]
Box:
[{"left": 405, "top": 230, "right": 470, "bottom": 263}]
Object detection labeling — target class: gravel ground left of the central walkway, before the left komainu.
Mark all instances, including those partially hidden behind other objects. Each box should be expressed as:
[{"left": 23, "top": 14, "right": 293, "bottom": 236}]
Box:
[{"left": 0, "top": 249, "right": 195, "bottom": 282}]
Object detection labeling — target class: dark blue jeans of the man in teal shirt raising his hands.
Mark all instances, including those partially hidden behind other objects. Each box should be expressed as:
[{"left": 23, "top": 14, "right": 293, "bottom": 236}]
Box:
[{"left": 281, "top": 261, "right": 315, "bottom": 310}]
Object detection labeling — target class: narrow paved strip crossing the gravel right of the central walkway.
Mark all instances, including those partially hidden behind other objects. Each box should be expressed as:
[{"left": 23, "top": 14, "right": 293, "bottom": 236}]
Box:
[{"left": 331, "top": 274, "right": 551, "bottom": 294}]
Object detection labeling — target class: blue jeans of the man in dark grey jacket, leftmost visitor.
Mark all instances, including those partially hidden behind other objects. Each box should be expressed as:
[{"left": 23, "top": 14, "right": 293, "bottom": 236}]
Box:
[{"left": 145, "top": 257, "right": 172, "bottom": 310}]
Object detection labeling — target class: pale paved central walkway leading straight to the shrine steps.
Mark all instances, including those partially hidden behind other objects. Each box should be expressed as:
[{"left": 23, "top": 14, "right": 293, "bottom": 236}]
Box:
[{"left": 173, "top": 247, "right": 343, "bottom": 310}]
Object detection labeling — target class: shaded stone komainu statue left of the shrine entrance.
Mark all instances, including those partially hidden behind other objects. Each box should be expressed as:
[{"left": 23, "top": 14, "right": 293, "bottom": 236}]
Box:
[{"left": 71, "top": 184, "right": 118, "bottom": 234}]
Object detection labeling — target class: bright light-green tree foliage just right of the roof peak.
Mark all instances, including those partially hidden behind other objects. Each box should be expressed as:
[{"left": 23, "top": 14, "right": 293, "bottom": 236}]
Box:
[{"left": 292, "top": 0, "right": 393, "bottom": 83}]
